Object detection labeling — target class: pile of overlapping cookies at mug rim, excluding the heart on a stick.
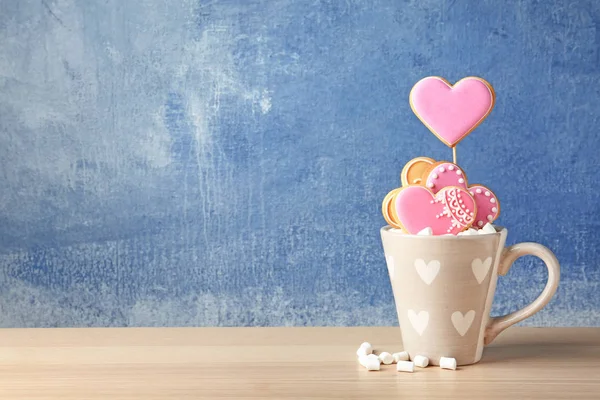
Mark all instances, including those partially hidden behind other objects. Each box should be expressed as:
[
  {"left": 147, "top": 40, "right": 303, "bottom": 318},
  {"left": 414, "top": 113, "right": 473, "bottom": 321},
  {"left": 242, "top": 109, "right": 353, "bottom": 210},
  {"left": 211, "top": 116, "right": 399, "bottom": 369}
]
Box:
[{"left": 382, "top": 157, "right": 500, "bottom": 235}]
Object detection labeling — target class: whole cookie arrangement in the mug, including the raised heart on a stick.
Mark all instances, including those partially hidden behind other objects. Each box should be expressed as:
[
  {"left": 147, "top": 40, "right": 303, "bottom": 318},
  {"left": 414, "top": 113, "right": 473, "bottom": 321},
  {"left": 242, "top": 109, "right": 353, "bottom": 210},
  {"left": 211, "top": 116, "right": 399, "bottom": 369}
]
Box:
[{"left": 382, "top": 76, "right": 500, "bottom": 235}]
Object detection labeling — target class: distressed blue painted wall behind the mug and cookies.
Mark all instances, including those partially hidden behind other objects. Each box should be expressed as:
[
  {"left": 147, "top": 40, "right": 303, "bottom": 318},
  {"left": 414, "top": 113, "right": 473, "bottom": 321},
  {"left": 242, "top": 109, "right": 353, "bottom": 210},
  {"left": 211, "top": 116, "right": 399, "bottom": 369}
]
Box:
[{"left": 0, "top": 0, "right": 600, "bottom": 327}]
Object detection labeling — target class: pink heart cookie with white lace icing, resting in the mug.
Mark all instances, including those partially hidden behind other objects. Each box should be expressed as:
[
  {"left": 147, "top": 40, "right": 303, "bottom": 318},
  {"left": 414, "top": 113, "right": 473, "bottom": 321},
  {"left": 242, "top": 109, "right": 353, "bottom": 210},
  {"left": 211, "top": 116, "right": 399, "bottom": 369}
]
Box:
[{"left": 393, "top": 185, "right": 476, "bottom": 235}]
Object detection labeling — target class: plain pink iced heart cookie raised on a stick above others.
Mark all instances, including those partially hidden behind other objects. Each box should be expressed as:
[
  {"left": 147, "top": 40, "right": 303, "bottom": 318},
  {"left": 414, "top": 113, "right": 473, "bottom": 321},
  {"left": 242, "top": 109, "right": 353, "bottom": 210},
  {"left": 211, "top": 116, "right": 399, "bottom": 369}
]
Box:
[{"left": 410, "top": 76, "right": 494, "bottom": 147}]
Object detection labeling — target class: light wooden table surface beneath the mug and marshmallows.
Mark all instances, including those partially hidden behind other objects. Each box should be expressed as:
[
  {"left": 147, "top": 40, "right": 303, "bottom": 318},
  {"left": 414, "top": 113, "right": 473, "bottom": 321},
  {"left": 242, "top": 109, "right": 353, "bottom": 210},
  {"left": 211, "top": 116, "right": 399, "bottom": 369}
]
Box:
[{"left": 0, "top": 327, "right": 600, "bottom": 400}]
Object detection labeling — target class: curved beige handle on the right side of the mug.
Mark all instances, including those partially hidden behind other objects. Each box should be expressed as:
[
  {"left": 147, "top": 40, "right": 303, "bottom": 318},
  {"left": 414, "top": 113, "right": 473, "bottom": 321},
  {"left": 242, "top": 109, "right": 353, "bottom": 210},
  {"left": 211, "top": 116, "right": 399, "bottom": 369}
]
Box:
[{"left": 484, "top": 242, "right": 560, "bottom": 344}]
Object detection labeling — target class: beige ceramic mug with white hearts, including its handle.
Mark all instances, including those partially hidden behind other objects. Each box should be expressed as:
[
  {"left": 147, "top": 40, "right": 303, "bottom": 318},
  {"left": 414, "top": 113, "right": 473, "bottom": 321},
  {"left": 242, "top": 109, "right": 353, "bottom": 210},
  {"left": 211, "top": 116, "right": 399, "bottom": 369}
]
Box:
[{"left": 381, "top": 226, "right": 560, "bottom": 365}]
